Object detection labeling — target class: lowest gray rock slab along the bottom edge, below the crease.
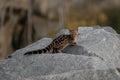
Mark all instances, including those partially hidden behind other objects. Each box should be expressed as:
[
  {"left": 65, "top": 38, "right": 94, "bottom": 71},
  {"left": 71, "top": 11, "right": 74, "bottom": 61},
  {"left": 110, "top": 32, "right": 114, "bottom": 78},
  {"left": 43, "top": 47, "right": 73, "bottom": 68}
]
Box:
[{"left": 21, "top": 69, "right": 120, "bottom": 80}]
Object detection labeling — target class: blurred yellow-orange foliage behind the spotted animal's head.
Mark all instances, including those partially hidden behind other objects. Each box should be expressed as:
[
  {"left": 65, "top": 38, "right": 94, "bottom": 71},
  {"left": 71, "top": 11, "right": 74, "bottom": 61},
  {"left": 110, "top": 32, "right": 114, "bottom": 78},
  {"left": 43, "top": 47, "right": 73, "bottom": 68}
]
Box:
[{"left": 66, "top": 9, "right": 107, "bottom": 28}]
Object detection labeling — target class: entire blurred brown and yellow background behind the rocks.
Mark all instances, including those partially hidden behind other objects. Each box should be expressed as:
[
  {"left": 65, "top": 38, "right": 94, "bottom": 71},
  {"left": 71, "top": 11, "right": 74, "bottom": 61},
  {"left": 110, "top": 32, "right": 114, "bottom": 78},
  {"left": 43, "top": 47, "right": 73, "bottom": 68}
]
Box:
[{"left": 0, "top": 0, "right": 120, "bottom": 59}]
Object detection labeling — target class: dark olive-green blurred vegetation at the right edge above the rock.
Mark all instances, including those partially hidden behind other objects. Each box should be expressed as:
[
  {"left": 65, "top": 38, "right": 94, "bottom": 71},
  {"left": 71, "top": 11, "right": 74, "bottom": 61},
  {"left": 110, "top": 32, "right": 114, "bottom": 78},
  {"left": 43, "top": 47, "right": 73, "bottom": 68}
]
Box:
[{"left": 103, "top": 7, "right": 120, "bottom": 34}]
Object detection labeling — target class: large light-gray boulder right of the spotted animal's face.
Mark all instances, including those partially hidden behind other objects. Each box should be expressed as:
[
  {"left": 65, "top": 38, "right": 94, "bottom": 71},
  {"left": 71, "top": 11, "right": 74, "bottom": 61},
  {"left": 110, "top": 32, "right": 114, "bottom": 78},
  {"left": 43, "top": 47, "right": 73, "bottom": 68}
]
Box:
[{"left": 78, "top": 27, "right": 120, "bottom": 67}]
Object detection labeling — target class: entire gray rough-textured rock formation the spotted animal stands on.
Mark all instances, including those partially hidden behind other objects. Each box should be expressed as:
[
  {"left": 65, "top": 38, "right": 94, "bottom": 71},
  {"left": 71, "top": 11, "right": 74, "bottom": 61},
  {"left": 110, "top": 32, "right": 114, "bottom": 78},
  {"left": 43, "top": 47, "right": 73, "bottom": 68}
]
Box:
[{"left": 0, "top": 26, "right": 120, "bottom": 80}]
